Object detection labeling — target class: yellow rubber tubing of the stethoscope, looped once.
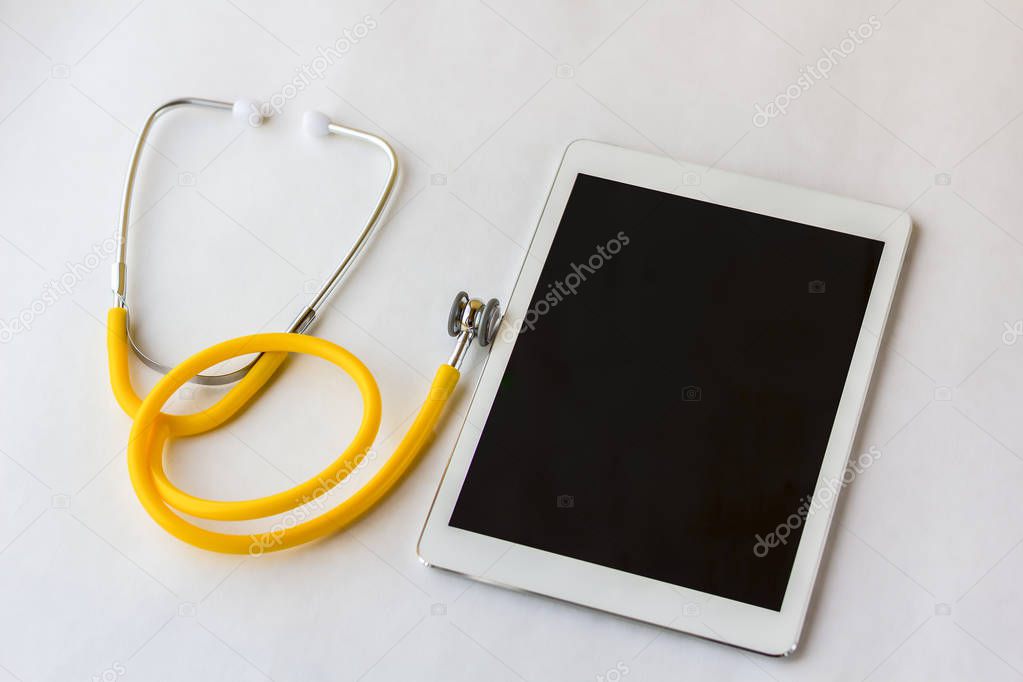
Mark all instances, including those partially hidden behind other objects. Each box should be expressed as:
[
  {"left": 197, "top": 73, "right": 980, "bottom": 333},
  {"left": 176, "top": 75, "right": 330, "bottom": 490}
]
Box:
[{"left": 107, "top": 308, "right": 459, "bottom": 554}]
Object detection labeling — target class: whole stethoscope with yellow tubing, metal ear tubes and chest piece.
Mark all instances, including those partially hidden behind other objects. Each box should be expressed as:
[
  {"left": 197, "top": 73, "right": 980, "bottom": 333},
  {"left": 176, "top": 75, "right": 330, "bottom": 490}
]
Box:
[{"left": 106, "top": 97, "right": 501, "bottom": 555}]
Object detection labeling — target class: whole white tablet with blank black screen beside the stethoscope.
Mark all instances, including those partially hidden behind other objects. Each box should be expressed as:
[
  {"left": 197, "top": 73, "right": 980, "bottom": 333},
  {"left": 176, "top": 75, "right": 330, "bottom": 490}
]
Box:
[{"left": 418, "top": 141, "right": 910, "bottom": 655}]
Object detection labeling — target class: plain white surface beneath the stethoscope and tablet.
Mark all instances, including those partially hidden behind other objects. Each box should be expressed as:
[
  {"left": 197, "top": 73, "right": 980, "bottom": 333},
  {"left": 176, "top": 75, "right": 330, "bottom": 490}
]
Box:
[{"left": 0, "top": 0, "right": 1023, "bottom": 682}]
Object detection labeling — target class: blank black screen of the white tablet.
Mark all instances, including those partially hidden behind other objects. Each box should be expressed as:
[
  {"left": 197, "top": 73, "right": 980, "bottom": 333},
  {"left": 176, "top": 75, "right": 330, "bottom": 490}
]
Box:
[{"left": 450, "top": 175, "right": 883, "bottom": 610}]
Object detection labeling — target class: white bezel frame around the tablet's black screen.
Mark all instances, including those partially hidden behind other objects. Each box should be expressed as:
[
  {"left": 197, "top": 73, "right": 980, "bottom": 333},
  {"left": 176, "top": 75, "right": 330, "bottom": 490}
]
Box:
[{"left": 417, "top": 140, "right": 911, "bottom": 655}]
